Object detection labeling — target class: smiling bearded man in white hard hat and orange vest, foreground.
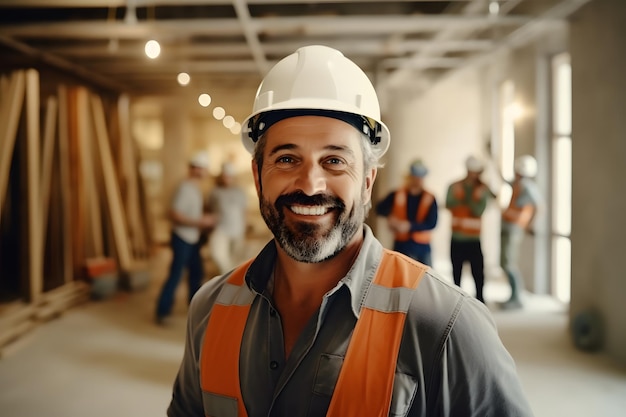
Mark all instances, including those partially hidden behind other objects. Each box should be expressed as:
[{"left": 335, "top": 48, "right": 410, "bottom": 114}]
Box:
[{"left": 168, "top": 46, "right": 531, "bottom": 417}]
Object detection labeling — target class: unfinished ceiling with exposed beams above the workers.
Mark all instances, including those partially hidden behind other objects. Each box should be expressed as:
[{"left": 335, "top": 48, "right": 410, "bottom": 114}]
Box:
[{"left": 0, "top": 0, "right": 591, "bottom": 95}]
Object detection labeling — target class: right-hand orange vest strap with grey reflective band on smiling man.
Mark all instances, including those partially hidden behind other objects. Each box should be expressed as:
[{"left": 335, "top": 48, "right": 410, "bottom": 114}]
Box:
[{"left": 326, "top": 250, "right": 427, "bottom": 417}]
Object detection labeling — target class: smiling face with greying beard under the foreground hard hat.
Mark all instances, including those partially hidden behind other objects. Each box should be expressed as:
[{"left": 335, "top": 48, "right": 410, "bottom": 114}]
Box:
[{"left": 252, "top": 116, "right": 376, "bottom": 263}]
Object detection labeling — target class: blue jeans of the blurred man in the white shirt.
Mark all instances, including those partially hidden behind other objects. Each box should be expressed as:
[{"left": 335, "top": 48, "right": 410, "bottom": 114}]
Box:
[{"left": 156, "top": 233, "right": 204, "bottom": 317}]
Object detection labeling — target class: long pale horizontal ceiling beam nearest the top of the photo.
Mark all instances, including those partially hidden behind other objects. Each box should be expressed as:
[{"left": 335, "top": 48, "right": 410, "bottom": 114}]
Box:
[{"left": 0, "top": 15, "right": 532, "bottom": 39}]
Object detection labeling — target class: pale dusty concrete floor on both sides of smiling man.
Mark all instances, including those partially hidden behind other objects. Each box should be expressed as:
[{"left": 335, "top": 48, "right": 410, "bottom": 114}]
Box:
[{"left": 0, "top": 247, "right": 626, "bottom": 417}]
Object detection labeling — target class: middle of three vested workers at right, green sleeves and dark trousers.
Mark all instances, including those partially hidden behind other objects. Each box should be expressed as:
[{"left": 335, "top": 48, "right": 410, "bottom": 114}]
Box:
[{"left": 446, "top": 156, "right": 493, "bottom": 303}]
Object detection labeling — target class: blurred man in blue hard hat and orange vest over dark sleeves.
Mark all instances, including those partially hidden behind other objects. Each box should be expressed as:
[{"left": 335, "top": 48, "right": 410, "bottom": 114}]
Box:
[{"left": 376, "top": 159, "right": 438, "bottom": 266}]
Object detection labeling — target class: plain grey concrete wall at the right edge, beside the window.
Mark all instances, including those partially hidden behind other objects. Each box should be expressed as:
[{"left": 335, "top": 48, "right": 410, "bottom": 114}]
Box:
[{"left": 570, "top": 0, "right": 626, "bottom": 363}]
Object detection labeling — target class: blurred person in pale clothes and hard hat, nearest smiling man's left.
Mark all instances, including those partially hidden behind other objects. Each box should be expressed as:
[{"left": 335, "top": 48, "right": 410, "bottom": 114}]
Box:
[{"left": 208, "top": 162, "right": 248, "bottom": 274}]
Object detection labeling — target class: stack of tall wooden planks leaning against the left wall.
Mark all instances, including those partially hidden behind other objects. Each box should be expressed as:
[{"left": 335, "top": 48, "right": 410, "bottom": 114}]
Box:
[{"left": 0, "top": 69, "right": 152, "bottom": 349}]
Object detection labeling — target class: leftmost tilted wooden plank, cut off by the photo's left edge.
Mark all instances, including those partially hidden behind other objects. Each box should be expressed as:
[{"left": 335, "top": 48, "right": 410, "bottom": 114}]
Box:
[{"left": 0, "top": 71, "right": 26, "bottom": 218}]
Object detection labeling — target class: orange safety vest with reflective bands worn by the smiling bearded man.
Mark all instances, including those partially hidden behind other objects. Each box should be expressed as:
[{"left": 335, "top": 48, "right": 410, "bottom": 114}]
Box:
[{"left": 200, "top": 249, "right": 427, "bottom": 417}]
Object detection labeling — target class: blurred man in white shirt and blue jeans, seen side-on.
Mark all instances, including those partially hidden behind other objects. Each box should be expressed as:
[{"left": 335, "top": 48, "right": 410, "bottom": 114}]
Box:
[{"left": 155, "top": 152, "right": 215, "bottom": 325}]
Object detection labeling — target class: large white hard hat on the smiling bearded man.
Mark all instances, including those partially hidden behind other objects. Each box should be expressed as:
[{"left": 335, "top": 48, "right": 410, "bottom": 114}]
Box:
[{"left": 241, "top": 45, "right": 390, "bottom": 157}]
